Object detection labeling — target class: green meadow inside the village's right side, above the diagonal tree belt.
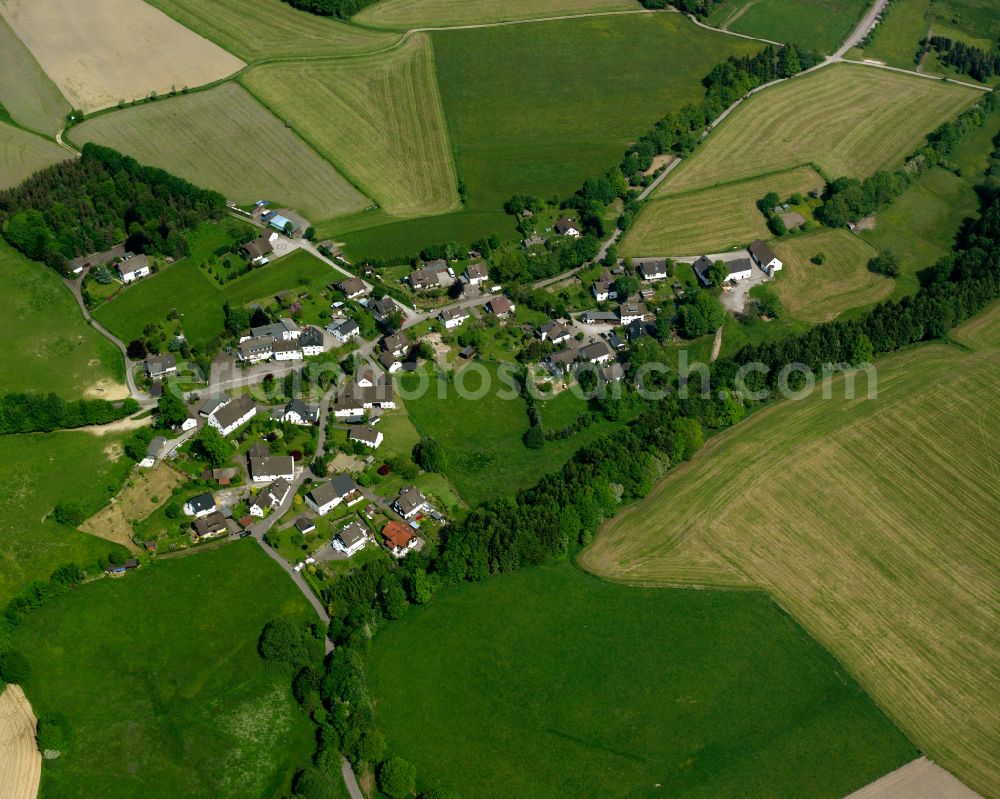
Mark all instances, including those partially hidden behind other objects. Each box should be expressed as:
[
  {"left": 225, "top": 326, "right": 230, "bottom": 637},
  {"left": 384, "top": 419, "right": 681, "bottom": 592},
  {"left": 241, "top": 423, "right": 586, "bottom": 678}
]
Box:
[{"left": 398, "top": 364, "right": 614, "bottom": 506}]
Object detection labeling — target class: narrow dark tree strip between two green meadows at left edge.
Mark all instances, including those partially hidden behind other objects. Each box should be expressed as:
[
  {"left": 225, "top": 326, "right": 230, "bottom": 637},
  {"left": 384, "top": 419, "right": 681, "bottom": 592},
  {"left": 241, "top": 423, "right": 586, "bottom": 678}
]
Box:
[{"left": 0, "top": 393, "right": 139, "bottom": 435}]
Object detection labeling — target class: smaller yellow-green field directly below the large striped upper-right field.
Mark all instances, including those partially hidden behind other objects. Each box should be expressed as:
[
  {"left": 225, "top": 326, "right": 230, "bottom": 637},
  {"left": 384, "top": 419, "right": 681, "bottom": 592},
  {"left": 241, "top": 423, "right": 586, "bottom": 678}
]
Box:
[{"left": 619, "top": 166, "right": 825, "bottom": 256}]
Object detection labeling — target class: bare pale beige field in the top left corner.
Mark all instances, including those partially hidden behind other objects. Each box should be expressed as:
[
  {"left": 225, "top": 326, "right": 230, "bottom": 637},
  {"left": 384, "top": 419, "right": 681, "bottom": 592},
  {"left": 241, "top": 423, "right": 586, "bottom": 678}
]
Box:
[{"left": 0, "top": 0, "right": 243, "bottom": 112}]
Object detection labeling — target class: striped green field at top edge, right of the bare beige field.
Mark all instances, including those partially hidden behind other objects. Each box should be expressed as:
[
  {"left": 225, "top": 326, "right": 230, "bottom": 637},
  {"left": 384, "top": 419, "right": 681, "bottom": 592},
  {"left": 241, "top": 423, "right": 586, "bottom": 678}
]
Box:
[{"left": 147, "top": 0, "right": 400, "bottom": 63}]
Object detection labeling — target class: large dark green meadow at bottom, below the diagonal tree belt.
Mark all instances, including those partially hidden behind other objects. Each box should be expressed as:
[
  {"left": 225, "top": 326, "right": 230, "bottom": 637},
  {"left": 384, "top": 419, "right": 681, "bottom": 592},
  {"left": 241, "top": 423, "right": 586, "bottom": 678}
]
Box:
[{"left": 369, "top": 564, "right": 916, "bottom": 799}]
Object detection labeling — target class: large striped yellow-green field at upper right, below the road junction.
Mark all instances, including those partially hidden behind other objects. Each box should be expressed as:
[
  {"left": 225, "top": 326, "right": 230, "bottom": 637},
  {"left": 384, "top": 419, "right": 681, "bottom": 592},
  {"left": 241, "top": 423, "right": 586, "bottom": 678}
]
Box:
[{"left": 658, "top": 64, "right": 979, "bottom": 193}]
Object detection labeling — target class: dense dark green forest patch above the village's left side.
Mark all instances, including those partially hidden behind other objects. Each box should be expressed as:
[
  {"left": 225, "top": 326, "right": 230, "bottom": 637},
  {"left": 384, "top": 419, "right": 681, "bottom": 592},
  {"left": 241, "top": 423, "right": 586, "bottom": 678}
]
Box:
[{"left": 0, "top": 144, "right": 226, "bottom": 272}]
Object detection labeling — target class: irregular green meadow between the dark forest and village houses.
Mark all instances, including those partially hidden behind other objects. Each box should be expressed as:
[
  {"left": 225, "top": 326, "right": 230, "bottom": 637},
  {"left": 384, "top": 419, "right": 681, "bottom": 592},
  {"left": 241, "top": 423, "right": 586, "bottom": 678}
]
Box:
[{"left": 94, "top": 239, "right": 339, "bottom": 346}]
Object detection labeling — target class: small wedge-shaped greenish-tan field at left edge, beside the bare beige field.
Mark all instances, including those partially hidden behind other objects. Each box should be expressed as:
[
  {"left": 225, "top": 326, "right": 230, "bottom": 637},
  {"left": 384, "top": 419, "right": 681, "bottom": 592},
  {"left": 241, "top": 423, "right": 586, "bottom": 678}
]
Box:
[{"left": 0, "top": 16, "right": 70, "bottom": 136}]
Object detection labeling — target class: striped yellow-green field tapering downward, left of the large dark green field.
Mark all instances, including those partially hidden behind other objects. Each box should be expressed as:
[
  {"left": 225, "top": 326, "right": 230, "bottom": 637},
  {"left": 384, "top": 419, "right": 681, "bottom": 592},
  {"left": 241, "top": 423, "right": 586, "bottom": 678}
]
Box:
[{"left": 245, "top": 34, "right": 459, "bottom": 217}]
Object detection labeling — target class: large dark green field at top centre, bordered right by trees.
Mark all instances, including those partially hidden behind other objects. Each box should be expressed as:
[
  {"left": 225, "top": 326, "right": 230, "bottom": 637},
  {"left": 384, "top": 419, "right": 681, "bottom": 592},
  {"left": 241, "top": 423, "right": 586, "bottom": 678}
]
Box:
[{"left": 332, "top": 13, "right": 759, "bottom": 256}]
